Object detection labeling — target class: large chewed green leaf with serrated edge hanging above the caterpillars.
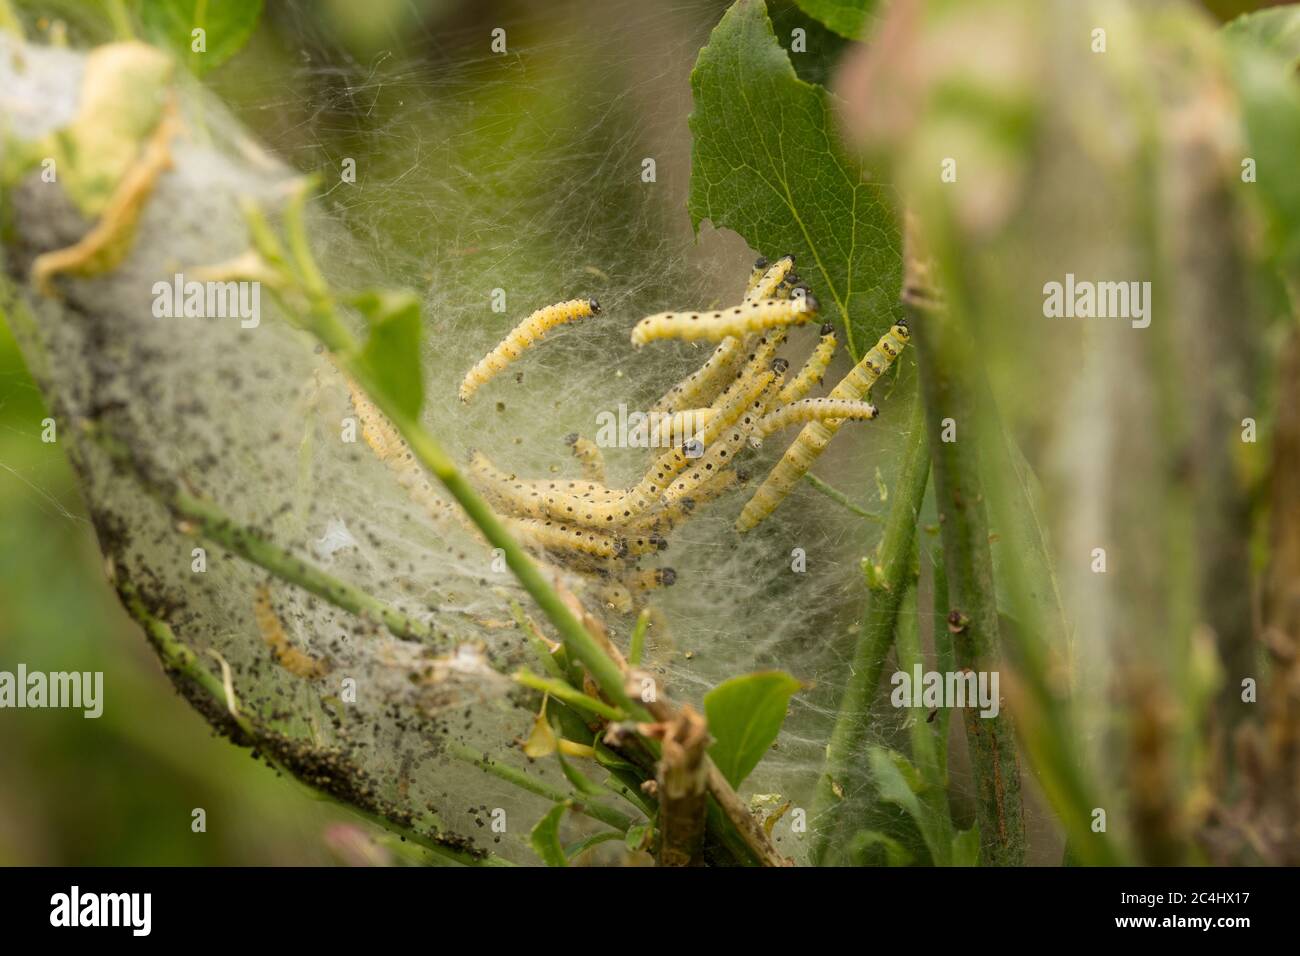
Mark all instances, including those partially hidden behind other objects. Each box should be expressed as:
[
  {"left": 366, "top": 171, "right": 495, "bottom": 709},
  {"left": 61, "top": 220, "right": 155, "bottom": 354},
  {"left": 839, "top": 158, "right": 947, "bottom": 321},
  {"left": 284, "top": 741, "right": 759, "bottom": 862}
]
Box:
[{"left": 688, "top": 0, "right": 901, "bottom": 358}]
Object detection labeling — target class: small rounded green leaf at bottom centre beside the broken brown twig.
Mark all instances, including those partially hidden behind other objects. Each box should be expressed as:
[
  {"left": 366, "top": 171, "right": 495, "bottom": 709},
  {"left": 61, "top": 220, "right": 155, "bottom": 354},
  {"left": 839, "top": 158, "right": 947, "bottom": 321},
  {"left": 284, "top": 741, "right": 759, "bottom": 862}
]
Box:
[{"left": 705, "top": 671, "right": 802, "bottom": 787}]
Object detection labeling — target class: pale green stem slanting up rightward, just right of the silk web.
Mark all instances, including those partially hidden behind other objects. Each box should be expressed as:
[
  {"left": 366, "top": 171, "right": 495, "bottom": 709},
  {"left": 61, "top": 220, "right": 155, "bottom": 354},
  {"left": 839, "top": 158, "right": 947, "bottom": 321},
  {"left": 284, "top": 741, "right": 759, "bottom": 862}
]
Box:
[{"left": 810, "top": 397, "right": 930, "bottom": 866}]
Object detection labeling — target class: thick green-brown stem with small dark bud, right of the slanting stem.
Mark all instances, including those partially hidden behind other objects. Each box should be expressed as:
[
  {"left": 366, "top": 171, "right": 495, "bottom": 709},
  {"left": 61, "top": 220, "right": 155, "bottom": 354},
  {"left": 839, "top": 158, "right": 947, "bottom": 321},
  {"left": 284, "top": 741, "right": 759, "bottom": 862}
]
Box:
[{"left": 904, "top": 293, "right": 1024, "bottom": 866}]
